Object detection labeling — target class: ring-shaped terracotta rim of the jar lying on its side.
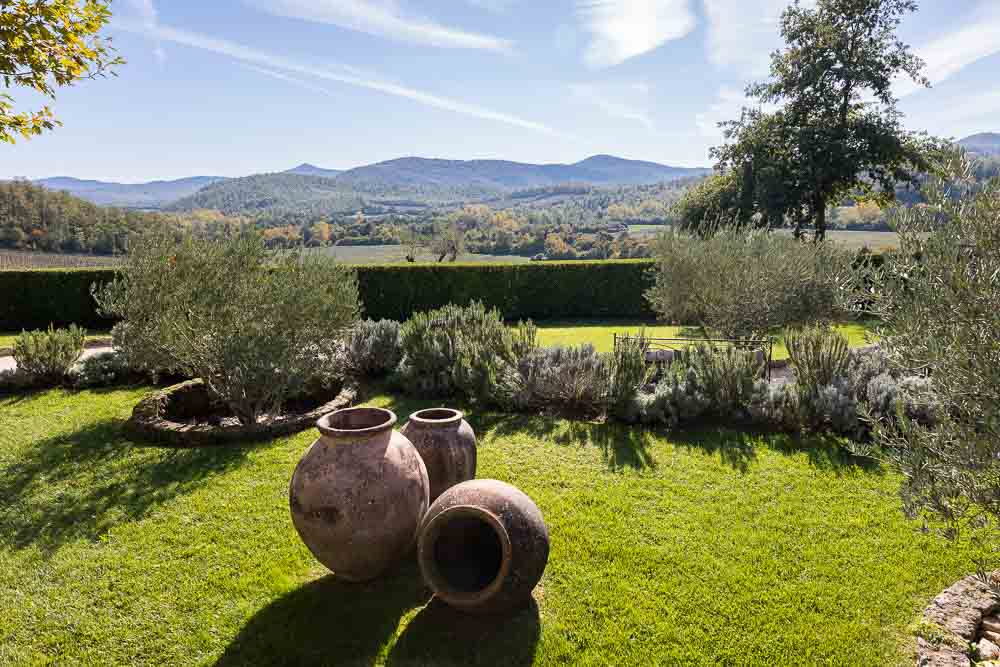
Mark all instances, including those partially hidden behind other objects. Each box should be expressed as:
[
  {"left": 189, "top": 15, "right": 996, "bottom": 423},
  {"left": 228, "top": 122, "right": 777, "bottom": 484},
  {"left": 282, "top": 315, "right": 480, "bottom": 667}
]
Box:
[{"left": 417, "top": 505, "right": 513, "bottom": 607}]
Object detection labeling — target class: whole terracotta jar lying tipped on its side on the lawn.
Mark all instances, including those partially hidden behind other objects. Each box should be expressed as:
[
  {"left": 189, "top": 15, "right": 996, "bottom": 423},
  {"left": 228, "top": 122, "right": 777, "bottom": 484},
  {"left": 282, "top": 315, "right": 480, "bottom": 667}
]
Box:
[{"left": 417, "top": 479, "right": 549, "bottom": 614}]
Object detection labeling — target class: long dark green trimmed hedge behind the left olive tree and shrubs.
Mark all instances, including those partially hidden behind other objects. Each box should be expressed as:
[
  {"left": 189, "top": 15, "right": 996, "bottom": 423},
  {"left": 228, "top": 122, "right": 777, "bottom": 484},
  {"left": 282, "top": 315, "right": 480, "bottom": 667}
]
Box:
[{"left": 0, "top": 260, "right": 654, "bottom": 331}]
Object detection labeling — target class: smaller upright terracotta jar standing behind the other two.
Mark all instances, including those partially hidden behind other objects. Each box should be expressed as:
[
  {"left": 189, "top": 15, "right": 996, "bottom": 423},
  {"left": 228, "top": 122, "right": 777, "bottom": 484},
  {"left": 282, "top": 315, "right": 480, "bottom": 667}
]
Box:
[{"left": 401, "top": 408, "right": 476, "bottom": 502}]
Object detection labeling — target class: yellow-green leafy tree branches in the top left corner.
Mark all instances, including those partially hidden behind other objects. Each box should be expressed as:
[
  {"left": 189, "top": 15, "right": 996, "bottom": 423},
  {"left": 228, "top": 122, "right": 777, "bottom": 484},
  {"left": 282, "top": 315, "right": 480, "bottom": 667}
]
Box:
[{"left": 0, "top": 0, "right": 124, "bottom": 143}]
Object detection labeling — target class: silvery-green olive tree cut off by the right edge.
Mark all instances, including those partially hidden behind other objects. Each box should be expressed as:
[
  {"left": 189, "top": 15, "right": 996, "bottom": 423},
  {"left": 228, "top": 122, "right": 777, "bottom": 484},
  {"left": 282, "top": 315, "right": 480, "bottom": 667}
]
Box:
[{"left": 873, "top": 156, "right": 1000, "bottom": 528}]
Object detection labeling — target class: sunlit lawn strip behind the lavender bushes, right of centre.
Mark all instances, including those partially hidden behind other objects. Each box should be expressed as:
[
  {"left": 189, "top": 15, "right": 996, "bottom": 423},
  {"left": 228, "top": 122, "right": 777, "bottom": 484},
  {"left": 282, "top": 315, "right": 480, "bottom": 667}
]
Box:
[{"left": 537, "top": 320, "right": 870, "bottom": 359}]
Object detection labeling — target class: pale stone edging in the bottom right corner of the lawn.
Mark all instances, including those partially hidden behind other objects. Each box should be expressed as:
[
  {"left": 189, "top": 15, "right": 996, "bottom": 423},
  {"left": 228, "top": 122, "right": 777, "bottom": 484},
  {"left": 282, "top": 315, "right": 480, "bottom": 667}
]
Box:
[{"left": 917, "top": 573, "right": 1000, "bottom": 667}]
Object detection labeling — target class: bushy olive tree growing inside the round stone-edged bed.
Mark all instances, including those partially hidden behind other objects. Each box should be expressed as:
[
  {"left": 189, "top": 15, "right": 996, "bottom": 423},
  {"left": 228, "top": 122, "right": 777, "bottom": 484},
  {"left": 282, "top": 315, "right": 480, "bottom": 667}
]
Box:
[{"left": 95, "top": 235, "right": 358, "bottom": 424}]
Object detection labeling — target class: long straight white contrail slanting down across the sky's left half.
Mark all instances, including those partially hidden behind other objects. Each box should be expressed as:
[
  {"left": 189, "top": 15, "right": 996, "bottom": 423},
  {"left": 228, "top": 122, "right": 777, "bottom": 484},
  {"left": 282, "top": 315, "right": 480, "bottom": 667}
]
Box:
[{"left": 114, "top": 21, "right": 571, "bottom": 138}]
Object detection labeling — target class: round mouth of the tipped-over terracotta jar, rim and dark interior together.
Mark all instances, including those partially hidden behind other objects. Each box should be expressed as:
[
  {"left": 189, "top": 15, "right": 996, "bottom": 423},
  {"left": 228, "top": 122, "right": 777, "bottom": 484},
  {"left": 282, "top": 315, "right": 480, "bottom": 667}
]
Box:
[{"left": 419, "top": 505, "right": 511, "bottom": 606}]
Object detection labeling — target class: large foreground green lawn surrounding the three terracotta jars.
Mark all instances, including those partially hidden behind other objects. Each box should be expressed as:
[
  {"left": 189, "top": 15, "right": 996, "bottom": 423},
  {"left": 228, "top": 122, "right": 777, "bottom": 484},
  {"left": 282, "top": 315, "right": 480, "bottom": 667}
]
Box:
[{"left": 0, "top": 389, "right": 984, "bottom": 665}]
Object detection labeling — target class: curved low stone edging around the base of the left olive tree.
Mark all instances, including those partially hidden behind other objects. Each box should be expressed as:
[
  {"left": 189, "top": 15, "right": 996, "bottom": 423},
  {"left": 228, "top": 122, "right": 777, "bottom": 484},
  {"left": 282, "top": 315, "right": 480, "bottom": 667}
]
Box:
[{"left": 125, "top": 379, "right": 360, "bottom": 447}]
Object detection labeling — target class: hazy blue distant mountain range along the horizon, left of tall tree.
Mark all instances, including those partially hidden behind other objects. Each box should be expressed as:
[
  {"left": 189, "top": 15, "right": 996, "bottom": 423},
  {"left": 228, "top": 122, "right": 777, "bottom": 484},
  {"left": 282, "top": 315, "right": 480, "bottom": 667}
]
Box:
[{"left": 35, "top": 155, "right": 710, "bottom": 208}]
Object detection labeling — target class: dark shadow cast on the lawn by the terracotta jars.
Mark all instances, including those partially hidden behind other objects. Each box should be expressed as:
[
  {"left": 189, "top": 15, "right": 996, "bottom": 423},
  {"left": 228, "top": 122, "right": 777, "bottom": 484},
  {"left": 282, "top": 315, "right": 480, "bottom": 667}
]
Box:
[{"left": 215, "top": 560, "right": 539, "bottom": 667}]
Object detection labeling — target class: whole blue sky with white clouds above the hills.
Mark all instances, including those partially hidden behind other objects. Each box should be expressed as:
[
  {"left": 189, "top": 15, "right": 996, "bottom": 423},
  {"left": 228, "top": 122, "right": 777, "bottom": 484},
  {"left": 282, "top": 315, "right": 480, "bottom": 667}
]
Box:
[{"left": 0, "top": 0, "right": 1000, "bottom": 182}]
